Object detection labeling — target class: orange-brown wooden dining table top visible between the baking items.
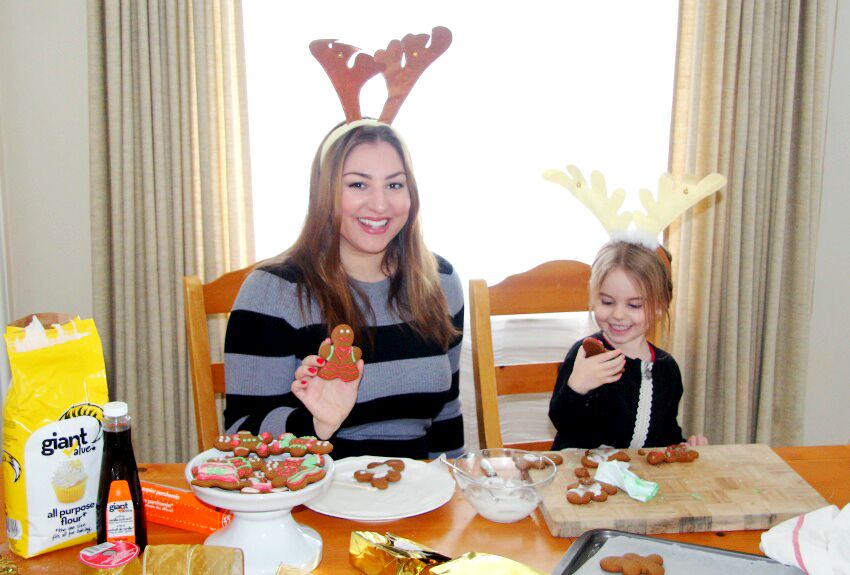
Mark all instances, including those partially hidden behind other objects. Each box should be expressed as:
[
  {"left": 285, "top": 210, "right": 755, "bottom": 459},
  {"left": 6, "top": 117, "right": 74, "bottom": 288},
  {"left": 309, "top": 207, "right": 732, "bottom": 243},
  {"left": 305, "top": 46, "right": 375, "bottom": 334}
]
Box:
[{"left": 0, "top": 445, "right": 850, "bottom": 574}]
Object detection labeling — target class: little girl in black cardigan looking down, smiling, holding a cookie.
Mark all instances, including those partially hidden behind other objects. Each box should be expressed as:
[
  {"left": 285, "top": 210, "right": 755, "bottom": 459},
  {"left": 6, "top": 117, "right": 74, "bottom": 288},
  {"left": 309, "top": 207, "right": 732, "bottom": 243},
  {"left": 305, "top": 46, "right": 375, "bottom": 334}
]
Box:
[{"left": 549, "top": 241, "right": 708, "bottom": 450}]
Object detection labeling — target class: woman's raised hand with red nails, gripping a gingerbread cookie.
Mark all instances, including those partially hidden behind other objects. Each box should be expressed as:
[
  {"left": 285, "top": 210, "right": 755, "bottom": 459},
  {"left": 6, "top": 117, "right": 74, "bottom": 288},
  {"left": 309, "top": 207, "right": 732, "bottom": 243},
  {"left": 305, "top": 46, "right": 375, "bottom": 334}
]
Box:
[{"left": 291, "top": 339, "right": 363, "bottom": 439}]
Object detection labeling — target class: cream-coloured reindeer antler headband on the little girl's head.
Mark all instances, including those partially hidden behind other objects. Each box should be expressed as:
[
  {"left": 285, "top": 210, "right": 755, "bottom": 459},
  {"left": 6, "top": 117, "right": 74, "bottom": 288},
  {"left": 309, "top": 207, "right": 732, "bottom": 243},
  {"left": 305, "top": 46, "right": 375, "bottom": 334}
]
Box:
[{"left": 543, "top": 165, "right": 726, "bottom": 250}]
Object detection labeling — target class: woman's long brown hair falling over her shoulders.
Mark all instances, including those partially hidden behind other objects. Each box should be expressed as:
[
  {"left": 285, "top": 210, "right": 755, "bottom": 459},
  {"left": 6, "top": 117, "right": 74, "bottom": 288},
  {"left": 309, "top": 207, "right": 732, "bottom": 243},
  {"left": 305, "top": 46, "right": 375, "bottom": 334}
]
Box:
[{"left": 284, "top": 125, "right": 458, "bottom": 349}]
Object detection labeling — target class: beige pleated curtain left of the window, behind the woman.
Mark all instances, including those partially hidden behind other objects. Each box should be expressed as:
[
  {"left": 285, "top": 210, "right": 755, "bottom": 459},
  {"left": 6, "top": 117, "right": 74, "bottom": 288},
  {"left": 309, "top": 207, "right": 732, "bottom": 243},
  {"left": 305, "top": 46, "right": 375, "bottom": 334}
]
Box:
[{"left": 89, "top": 0, "right": 254, "bottom": 461}]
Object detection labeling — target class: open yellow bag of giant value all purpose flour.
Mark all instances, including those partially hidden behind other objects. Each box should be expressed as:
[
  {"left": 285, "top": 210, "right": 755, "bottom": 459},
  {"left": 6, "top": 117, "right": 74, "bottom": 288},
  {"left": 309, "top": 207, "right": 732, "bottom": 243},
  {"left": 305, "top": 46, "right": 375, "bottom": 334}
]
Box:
[{"left": 3, "top": 319, "right": 109, "bottom": 557}]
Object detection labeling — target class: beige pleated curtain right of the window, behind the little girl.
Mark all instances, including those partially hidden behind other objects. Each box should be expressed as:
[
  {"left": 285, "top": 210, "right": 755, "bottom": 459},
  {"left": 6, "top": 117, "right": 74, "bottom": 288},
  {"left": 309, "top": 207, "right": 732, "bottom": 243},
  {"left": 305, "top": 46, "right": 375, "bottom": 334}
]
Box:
[{"left": 667, "top": 0, "right": 827, "bottom": 445}]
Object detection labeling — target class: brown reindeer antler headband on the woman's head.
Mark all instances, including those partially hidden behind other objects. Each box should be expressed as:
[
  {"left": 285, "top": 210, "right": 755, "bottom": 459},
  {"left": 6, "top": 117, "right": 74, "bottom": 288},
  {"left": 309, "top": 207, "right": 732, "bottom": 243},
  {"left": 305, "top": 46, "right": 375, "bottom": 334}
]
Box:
[{"left": 310, "top": 26, "right": 452, "bottom": 158}]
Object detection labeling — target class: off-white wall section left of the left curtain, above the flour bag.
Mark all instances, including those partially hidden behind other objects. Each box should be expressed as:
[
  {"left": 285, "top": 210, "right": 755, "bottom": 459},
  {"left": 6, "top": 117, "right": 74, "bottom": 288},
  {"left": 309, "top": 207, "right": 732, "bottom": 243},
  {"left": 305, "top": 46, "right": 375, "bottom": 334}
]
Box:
[{"left": 0, "top": 0, "right": 92, "bottom": 319}]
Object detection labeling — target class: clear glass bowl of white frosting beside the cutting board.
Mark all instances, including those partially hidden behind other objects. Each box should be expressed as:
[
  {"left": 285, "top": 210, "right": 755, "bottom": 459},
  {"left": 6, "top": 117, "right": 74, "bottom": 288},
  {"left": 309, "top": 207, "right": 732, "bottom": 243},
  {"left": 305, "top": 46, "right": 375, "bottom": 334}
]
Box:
[{"left": 452, "top": 448, "right": 558, "bottom": 523}]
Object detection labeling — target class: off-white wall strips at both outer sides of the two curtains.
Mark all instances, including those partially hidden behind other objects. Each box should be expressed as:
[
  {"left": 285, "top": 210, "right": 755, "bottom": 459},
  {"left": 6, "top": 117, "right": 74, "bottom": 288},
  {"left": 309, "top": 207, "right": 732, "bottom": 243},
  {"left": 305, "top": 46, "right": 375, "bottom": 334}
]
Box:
[{"left": 0, "top": 0, "right": 850, "bottom": 445}]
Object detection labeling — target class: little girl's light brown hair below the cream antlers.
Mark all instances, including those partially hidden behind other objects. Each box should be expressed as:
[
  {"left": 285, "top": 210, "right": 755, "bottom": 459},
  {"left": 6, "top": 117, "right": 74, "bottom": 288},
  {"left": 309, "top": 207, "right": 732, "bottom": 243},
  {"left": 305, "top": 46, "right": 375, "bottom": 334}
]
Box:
[{"left": 589, "top": 241, "right": 673, "bottom": 332}]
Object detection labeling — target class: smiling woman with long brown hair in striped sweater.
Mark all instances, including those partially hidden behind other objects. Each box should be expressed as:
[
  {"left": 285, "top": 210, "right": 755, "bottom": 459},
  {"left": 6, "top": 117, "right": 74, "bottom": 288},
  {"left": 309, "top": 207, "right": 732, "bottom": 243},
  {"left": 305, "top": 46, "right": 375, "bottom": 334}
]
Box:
[{"left": 225, "top": 124, "right": 463, "bottom": 458}]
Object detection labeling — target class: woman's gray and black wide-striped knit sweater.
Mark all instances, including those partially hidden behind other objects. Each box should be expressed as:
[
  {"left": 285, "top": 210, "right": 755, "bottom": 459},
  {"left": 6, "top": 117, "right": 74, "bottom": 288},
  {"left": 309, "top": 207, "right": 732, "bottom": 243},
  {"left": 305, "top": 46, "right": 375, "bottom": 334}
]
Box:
[{"left": 224, "top": 256, "right": 463, "bottom": 459}]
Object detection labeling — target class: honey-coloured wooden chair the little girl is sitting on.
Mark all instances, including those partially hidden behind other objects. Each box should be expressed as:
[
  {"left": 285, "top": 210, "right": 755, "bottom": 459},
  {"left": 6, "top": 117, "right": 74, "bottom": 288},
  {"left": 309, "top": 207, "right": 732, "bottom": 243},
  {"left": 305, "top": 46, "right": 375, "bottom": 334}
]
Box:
[{"left": 469, "top": 260, "right": 590, "bottom": 450}]
